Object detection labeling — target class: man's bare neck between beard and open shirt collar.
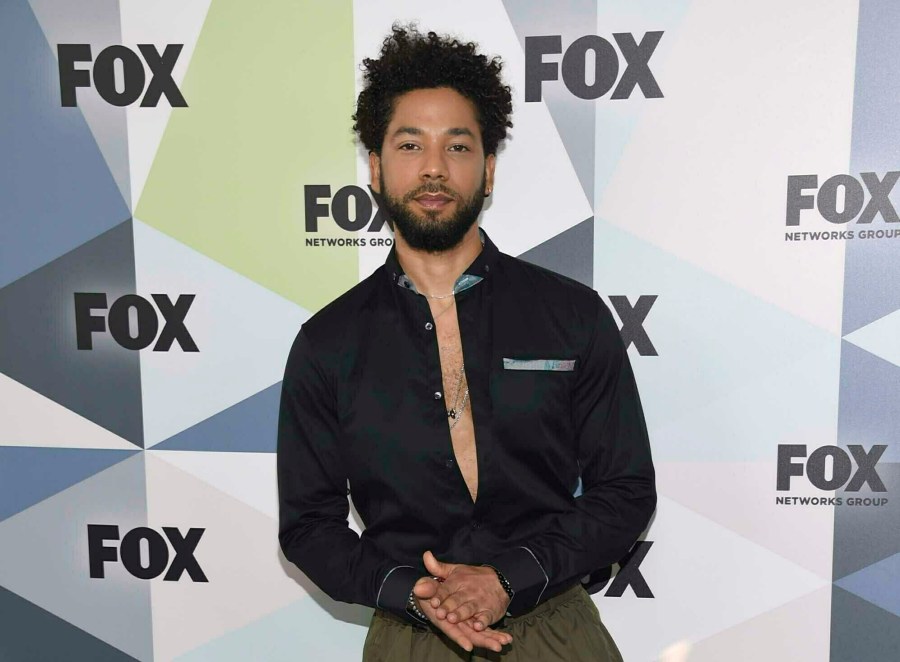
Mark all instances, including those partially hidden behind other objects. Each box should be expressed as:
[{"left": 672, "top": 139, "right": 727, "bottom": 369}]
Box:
[{"left": 394, "top": 223, "right": 482, "bottom": 296}]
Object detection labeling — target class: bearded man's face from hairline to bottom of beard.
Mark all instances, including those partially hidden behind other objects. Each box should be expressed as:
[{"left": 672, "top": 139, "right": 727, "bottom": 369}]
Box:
[{"left": 369, "top": 87, "right": 495, "bottom": 252}]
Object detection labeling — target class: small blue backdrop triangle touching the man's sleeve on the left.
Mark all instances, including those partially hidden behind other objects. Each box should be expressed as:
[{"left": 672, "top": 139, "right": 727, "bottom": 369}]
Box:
[{"left": 153, "top": 382, "right": 281, "bottom": 453}]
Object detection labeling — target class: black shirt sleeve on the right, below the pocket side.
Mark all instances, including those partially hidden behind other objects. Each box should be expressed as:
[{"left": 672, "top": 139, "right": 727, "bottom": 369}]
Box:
[{"left": 488, "top": 297, "right": 656, "bottom": 615}]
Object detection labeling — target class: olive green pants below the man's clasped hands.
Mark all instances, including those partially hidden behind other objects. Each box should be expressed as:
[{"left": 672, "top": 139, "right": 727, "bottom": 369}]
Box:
[{"left": 363, "top": 584, "right": 622, "bottom": 662}]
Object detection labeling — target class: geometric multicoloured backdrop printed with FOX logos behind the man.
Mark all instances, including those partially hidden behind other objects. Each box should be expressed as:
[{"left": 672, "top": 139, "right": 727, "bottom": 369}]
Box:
[{"left": 0, "top": 0, "right": 900, "bottom": 662}]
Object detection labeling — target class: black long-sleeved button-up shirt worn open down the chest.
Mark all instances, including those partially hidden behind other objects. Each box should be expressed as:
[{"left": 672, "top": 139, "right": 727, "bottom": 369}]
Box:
[{"left": 278, "top": 234, "right": 656, "bottom": 616}]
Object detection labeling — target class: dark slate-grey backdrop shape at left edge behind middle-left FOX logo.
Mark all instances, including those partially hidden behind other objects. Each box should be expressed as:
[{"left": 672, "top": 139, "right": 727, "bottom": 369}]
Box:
[{"left": 0, "top": 221, "right": 144, "bottom": 446}]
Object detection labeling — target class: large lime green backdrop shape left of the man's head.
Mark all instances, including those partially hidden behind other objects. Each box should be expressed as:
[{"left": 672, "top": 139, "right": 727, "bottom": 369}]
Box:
[{"left": 137, "top": 0, "right": 359, "bottom": 311}]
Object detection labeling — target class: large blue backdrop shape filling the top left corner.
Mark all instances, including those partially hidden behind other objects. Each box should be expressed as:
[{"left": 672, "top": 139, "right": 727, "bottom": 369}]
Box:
[{"left": 0, "top": 0, "right": 131, "bottom": 287}]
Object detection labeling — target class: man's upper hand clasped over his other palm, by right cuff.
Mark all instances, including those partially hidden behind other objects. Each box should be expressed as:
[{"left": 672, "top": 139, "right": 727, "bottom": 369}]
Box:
[{"left": 422, "top": 552, "right": 509, "bottom": 632}]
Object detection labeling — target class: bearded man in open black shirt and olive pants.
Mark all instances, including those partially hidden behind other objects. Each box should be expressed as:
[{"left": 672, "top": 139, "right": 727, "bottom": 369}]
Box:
[{"left": 278, "top": 26, "right": 656, "bottom": 662}]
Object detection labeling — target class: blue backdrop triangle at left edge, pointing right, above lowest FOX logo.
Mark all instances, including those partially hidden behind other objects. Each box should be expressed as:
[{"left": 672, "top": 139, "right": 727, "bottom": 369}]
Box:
[{"left": 0, "top": 446, "right": 137, "bottom": 521}]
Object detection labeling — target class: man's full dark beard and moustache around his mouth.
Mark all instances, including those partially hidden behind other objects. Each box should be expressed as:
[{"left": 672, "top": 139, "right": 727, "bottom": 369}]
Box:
[{"left": 379, "top": 174, "right": 485, "bottom": 253}]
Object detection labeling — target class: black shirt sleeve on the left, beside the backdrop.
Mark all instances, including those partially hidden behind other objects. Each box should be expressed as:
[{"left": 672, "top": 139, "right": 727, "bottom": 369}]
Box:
[{"left": 278, "top": 330, "right": 420, "bottom": 622}]
